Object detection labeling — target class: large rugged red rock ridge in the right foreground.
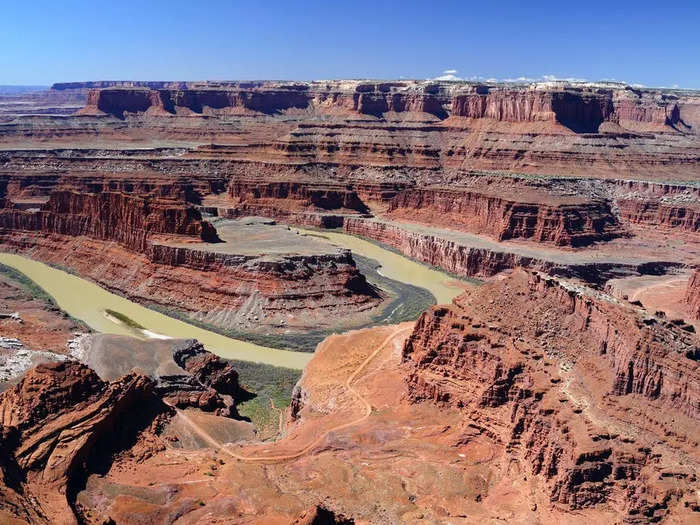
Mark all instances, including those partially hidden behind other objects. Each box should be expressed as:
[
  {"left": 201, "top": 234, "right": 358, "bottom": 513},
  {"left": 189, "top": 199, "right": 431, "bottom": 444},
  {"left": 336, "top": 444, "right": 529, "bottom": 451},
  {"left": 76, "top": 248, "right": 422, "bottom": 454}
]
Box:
[{"left": 403, "top": 270, "right": 700, "bottom": 523}]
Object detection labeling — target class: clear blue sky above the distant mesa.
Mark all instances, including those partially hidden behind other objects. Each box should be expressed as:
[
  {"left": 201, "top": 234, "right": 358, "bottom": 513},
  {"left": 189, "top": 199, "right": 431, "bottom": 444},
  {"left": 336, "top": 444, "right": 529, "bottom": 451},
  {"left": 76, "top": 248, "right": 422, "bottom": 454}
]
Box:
[{"left": 0, "top": 0, "right": 700, "bottom": 88}]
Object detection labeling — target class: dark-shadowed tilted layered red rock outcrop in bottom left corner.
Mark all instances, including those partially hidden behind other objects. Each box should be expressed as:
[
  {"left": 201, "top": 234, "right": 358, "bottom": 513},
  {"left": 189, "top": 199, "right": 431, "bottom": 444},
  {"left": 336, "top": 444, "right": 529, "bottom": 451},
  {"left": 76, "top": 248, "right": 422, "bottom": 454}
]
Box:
[{"left": 0, "top": 362, "right": 169, "bottom": 523}]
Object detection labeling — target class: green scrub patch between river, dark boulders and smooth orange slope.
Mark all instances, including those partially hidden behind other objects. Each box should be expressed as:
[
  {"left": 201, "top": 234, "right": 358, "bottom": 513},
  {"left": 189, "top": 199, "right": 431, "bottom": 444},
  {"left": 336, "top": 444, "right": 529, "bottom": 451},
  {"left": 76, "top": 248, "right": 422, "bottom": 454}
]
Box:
[{"left": 230, "top": 360, "right": 301, "bottom": 439}]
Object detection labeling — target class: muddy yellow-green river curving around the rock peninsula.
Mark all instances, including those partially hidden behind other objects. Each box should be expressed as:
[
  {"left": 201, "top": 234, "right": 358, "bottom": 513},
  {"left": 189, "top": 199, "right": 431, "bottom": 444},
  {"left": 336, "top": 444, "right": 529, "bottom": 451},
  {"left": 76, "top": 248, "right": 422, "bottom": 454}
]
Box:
[{"left": 0, "top": 230, "right": 463, "bottom": 369}]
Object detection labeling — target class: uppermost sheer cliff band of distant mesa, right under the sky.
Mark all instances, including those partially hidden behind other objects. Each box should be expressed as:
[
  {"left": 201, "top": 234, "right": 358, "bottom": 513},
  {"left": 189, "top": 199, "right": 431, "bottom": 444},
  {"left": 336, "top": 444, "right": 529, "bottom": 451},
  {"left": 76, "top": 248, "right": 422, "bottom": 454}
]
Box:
[{"left": 76, "top": 81, "right": 682, "bottom": 133}]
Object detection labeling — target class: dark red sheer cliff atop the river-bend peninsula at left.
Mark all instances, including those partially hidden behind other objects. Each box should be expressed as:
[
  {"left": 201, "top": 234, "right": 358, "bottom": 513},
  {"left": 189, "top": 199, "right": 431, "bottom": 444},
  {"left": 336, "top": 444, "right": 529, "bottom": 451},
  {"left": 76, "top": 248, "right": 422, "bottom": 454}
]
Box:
[{"left": 0, "top": 191, "right": 217, "bottom": 252}]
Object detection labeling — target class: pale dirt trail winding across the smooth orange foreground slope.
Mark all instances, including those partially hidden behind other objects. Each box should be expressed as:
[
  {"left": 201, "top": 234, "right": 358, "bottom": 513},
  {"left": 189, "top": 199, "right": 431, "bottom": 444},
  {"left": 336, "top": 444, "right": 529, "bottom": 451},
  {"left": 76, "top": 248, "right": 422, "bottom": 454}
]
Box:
[{"left": 177, "top": 326, "right": 413, "bottom": 462}]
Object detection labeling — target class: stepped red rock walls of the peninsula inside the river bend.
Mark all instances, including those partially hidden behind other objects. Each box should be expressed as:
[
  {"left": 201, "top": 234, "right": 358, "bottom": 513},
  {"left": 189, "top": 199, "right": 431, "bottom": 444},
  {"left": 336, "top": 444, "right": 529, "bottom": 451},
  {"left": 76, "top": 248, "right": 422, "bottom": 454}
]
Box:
[{"left": 0, "top": 190, "right": 382, "bottom": 328}]
